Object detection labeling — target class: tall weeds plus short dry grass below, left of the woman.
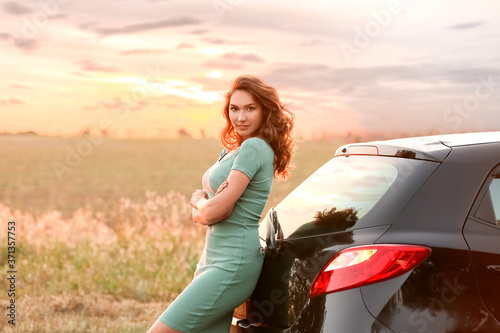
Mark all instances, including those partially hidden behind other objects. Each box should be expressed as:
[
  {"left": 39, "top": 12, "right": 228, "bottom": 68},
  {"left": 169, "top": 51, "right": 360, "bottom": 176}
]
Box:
[{"left": 0, "top": 192, "right": 205, "bottom": 332}]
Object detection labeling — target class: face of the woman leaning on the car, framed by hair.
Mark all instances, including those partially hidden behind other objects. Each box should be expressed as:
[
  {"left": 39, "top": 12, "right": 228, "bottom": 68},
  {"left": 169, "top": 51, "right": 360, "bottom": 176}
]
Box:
[{"left": 229, "top": 90, "right": 263, "bottom": 142}]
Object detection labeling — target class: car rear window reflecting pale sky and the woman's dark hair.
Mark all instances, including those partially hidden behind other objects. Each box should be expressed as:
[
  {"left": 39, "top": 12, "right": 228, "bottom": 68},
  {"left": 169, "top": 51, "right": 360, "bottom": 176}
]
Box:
[{"left": 261, "top": 156, "right": 439, "bottom": 237}]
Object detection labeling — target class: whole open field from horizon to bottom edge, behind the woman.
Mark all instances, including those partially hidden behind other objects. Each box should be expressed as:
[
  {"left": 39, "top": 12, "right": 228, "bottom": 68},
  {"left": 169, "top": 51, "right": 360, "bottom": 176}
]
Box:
[{"left": 0, "top": 136, "right": 341, "bottom": 332}]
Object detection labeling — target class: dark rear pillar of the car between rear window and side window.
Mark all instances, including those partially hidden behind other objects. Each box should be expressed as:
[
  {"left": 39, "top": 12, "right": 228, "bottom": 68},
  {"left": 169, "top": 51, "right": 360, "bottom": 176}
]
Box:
[{"left": 380, "top": 143, "right": 500, "bottom": 239}]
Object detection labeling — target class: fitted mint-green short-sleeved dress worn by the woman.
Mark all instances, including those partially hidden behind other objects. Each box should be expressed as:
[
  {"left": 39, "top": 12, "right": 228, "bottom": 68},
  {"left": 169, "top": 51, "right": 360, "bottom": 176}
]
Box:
[{"left": 159, "top": 138, "right": 274, "bottom": 333}]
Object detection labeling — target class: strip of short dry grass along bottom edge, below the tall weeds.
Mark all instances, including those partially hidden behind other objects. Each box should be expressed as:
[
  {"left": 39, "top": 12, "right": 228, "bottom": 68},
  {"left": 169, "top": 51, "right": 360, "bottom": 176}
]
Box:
[{"left": 0, "top": 293, "right": 165, "bottom": 333}]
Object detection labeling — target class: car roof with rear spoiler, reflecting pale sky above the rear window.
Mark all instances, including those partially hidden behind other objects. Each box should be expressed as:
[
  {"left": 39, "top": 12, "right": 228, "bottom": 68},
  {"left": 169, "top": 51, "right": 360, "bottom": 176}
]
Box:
[{"left": 335, "top": 131, "right": 500, "bottom": 162}]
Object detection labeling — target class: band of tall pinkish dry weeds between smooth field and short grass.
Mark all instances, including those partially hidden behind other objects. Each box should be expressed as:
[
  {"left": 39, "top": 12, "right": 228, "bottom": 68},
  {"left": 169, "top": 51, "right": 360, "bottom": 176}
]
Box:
[{"left": 0, "top": 191, "right": 205, "bottom": 301}]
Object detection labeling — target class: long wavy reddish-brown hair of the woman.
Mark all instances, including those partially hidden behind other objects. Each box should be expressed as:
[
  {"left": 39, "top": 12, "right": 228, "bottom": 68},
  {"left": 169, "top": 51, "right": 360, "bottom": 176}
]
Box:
[{"left": 220, "top": 75, "right": 295, "bottom": 180}]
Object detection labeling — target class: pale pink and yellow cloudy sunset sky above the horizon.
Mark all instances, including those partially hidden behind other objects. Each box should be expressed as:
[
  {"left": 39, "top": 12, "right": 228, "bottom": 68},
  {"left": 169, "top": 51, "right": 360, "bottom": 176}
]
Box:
[{"left": 0, "top": 0, "right": 500, "bottom": 138}]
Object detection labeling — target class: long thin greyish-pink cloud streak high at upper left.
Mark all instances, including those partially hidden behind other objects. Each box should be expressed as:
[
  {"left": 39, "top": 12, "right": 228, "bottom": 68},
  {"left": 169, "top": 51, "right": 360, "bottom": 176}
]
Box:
[{"left": 94, "top": 17, "right": 201, "bottom": 36}]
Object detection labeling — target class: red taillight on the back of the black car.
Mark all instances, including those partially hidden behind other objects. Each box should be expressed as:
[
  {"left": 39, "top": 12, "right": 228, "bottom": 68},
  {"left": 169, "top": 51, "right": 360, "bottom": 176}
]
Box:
[{"left": 309, "top": 244, "right": 431, "bottom": 297}]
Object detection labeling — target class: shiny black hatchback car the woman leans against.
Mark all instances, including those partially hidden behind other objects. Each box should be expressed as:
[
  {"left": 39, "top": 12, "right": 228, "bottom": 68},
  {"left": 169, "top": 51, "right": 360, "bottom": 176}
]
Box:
[{"left": 232, "top": 132, "right": 500, "bottom": 333}]
